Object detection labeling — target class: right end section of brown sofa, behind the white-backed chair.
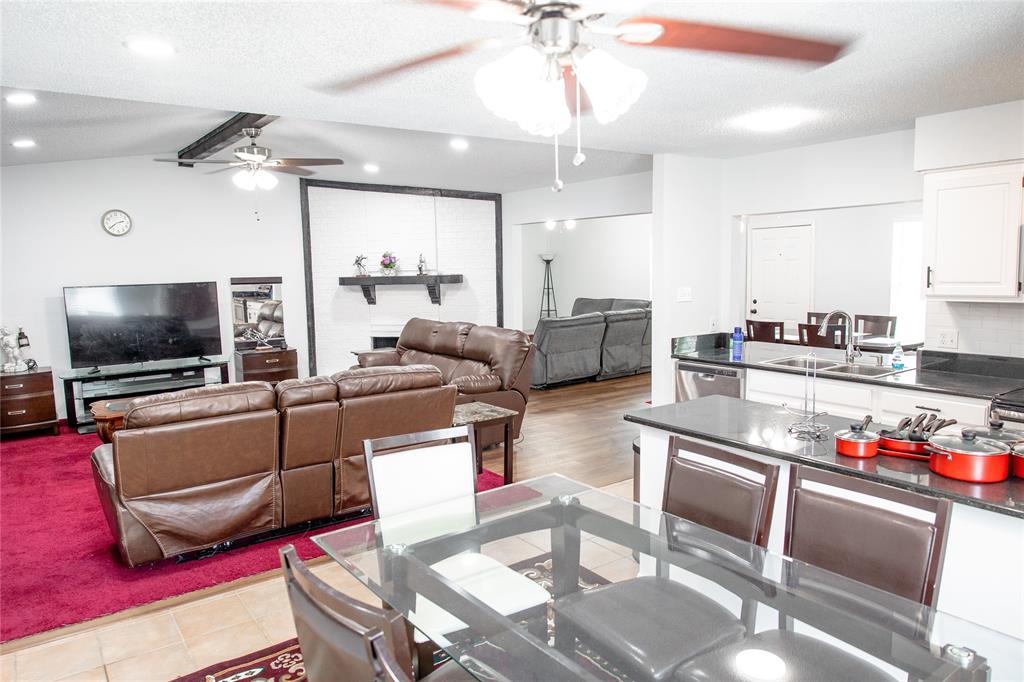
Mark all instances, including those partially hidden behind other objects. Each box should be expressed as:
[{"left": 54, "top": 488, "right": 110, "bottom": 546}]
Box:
[{"left": 331, "top": 365, "right": 457, "bottom": 515}]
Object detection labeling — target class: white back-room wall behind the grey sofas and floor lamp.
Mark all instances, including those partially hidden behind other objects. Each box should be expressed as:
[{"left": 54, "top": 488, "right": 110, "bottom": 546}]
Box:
[{"left": 521, "top": 213, "right": 651, "bottom": 331}]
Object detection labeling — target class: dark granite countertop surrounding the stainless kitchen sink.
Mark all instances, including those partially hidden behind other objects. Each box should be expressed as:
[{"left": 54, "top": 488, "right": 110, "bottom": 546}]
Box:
[{"left": 672, "top": 335, "right": 1024, "bottom": 400}]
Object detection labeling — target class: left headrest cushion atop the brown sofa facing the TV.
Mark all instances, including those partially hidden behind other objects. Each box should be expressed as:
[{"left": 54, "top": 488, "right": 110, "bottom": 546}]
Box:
[{"left": 125, "top": 381, "right": 278, "bottom": 429}]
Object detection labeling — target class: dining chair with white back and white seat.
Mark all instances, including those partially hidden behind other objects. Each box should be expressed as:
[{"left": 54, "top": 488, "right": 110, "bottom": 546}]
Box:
[{"left": 364, "top": 426, "right": 551, "bottom": 660}]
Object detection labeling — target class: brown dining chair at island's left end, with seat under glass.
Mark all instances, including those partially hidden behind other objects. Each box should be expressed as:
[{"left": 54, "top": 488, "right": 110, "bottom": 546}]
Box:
[{"left": 554, "top": 436, "right": 779, "bottom": 680}]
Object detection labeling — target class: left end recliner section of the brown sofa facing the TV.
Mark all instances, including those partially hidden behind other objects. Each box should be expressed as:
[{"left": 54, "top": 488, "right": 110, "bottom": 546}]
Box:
[{"left": 92, "top": 382, "right": 282, "bottom": 566}]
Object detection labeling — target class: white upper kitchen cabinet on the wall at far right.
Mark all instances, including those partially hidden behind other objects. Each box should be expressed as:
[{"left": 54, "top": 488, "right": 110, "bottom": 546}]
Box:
[{"left": 925, "top": 163, "right": 1024, "bottom": 301}]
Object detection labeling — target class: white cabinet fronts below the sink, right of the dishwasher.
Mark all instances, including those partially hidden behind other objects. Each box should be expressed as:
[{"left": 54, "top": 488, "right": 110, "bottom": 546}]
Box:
[{"left": 746, "top": 370, "right": 989, "bottom": 426}]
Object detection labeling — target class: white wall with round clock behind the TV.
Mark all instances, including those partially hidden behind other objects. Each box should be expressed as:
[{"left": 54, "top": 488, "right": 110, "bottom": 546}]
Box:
[{"left": 0, "top": 157, "right": 306, "bottom": 416}]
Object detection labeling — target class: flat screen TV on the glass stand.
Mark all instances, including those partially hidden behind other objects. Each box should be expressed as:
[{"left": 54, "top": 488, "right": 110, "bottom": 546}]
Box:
[{"left": 65, "top": 282, "right": 221, "bottom": 368}]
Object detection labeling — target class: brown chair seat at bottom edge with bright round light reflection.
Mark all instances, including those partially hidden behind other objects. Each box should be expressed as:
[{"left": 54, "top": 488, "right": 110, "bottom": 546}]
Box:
[{"left": 673, "top": 630, "right": 893, "bottom": 682}]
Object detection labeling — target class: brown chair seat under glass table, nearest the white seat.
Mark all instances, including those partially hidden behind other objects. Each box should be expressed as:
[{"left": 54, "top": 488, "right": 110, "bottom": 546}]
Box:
[{"left": 555, "top": 576, "right": 746, "bottom": 680}]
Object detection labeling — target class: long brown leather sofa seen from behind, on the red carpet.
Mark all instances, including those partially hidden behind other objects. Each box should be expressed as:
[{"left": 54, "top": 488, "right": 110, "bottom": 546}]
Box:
[{"left": 92, "top": 366, "right": 456, "bottom": 566}]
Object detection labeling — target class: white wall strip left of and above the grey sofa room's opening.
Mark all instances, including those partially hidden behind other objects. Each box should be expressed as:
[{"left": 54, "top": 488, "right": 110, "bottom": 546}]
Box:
[{"left": 502, "top": 172, "right": 652, "bottom": 329}]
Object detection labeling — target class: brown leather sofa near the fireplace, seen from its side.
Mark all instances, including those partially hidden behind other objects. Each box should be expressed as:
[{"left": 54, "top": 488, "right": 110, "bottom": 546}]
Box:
[{"left": 358, "top": 317, "right": 536, "bottom": 445}]
